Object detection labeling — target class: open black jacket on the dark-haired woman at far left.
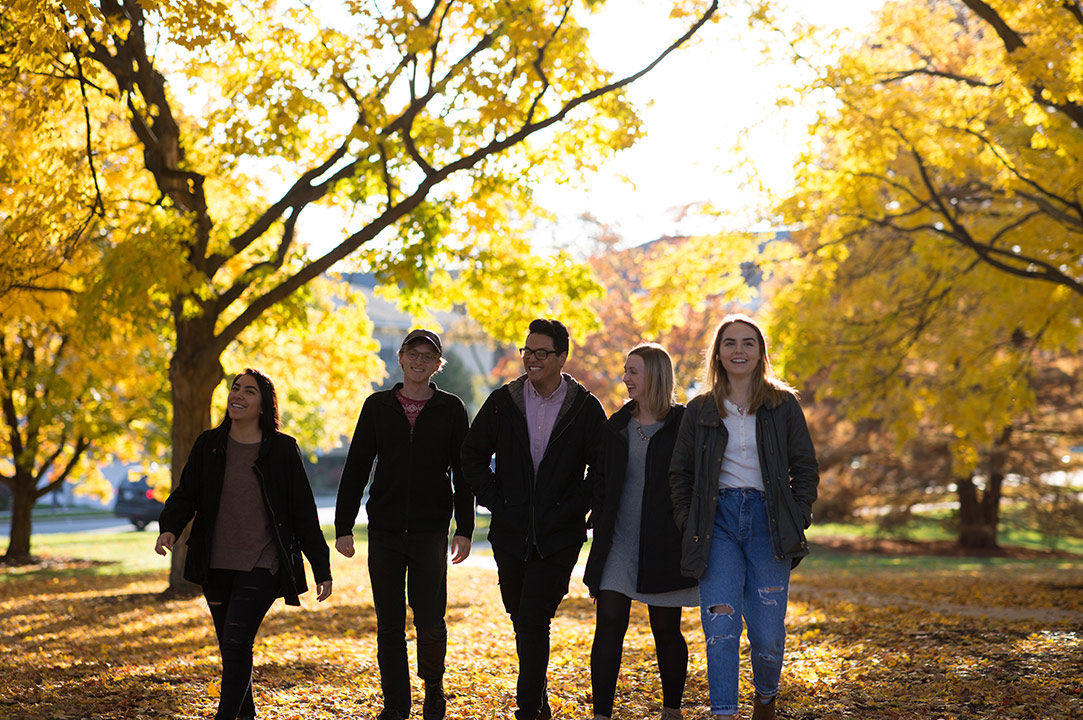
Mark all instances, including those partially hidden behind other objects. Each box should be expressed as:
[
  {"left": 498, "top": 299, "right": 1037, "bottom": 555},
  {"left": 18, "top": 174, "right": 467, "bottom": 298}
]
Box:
[{"left": 158, "top": 418, "right": 331, "bottom": 605}]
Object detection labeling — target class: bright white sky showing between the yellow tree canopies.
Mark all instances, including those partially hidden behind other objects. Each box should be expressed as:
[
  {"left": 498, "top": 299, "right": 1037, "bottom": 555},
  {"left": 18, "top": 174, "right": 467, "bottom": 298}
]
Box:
[{"left": 530, "top": 0, "right": 884, "bottom": 246}]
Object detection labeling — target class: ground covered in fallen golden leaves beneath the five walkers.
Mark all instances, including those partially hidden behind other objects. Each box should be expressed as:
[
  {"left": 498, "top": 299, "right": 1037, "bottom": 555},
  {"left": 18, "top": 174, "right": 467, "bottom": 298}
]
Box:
[{"left": 0, "top": 541, "right": 1083, "bottom": 720}]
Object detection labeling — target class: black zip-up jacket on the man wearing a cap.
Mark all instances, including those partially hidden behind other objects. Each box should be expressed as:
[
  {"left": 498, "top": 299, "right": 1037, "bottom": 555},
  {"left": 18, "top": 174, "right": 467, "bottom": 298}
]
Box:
[{"left": 335, "top": 382, "right": 474, "bottom": 539}]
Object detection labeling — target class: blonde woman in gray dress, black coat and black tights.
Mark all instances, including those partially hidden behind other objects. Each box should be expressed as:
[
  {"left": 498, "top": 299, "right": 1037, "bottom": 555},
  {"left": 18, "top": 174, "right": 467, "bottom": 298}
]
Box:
[{"left": 584, "top": 343, "right": 700, "bottom": 720}]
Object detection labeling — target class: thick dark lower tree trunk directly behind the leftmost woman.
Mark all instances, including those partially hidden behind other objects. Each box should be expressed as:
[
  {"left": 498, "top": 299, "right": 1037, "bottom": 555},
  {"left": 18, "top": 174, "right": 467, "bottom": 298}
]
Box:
[{"left": 168, "top": 316, "right": 223, "bottom": 594}]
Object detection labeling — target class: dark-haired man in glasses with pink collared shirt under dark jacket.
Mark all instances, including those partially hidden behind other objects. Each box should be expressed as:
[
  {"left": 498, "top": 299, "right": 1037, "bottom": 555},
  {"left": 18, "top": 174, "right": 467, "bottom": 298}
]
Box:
[{"left": 462, "top": 319, "right": 605, "bottom": 720}]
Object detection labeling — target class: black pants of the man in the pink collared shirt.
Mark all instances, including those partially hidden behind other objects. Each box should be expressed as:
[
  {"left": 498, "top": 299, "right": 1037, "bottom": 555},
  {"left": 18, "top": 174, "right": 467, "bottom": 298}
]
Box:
[{"left": 493, "top": 545, "right": 582, "bottom": 720}]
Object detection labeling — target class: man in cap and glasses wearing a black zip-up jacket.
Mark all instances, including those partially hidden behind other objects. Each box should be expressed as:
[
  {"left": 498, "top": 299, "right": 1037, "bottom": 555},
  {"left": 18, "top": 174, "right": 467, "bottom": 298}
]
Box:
[{"left": 335, "top": 329, "right": 474, "bottom": 720}]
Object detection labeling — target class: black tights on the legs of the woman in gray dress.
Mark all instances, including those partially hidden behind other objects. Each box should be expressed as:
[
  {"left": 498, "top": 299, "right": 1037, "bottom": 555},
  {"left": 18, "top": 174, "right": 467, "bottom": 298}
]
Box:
[{"left": 590, "top": 590, "right": 688, "bottom": 717}]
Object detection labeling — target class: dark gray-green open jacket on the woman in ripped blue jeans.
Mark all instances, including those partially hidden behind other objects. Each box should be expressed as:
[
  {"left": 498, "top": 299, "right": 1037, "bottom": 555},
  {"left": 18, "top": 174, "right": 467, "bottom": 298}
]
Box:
[{"left": 669, "top": 393, "right": 820, "bottom": 579}]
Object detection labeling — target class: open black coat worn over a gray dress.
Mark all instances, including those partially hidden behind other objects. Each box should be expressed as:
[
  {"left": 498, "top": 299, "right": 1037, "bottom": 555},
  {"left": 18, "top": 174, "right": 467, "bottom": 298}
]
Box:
[{"left": 583, "top": 403, "right": 696, "bottom": 595}]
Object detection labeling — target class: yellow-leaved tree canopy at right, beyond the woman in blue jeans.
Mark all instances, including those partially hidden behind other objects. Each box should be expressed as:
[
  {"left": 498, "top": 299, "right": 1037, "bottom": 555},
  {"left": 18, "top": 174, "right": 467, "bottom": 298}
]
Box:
[{"left": 762, "top": 1, "right": 1083, "bottom": 542}]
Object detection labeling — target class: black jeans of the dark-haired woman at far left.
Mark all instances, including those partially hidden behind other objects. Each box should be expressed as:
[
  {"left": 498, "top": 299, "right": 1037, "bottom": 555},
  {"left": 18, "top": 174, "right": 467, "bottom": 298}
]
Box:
[{"left": 203, "top": 567, "right": 278, "bottom": 720}]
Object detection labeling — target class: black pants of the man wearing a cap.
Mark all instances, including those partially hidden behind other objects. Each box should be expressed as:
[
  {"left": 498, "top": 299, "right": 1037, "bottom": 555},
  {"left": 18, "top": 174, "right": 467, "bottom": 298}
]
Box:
[{"left": 368, "top": 527, "right": 447, "bottom": 717}]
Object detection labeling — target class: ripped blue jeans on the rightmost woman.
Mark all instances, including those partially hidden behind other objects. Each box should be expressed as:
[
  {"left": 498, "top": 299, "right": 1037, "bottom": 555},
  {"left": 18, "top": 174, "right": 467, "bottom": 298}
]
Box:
[{"left": 700, "top": 488, "right": 790, "bottom": 715}]
